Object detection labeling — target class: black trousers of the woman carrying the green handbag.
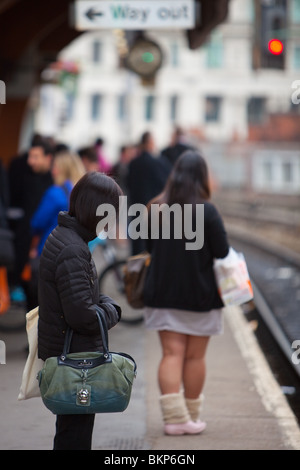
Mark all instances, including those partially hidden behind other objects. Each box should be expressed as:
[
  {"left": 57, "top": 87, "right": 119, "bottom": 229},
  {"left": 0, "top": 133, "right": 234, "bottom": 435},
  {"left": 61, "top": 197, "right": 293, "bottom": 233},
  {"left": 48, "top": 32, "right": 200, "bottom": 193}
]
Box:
[{"left": 53, "top": 414, "right": 95, "bottom": 450}]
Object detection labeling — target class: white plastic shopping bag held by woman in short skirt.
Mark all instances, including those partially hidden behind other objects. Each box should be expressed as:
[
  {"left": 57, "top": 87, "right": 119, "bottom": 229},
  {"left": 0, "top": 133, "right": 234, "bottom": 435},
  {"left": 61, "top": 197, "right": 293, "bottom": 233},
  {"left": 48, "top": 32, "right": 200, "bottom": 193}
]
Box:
[{"left": 214, "top": 247, "right": 253, "bottom": 306}]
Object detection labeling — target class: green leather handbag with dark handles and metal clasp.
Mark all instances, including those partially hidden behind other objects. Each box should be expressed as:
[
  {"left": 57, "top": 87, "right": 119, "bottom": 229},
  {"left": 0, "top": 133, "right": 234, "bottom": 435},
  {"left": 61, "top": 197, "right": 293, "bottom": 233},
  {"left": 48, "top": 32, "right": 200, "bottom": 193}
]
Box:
[{"left": 37, "top": 310, "right": 137, "bottom": 415}]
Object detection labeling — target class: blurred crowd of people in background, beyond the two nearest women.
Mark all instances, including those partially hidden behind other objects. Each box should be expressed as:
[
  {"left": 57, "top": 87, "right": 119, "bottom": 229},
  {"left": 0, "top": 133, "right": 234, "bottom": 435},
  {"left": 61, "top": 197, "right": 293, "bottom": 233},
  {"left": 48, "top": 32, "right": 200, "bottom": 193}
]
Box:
[{"left": 0, "top": 125, "right": 195, "bottom": 310}]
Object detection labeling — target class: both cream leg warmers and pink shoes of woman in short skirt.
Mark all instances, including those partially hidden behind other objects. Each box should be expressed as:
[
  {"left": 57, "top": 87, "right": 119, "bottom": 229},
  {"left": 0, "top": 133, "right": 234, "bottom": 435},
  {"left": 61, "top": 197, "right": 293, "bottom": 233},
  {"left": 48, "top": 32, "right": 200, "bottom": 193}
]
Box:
[{"left": 160, "top": 393, "right": 206, "bottom": 435}]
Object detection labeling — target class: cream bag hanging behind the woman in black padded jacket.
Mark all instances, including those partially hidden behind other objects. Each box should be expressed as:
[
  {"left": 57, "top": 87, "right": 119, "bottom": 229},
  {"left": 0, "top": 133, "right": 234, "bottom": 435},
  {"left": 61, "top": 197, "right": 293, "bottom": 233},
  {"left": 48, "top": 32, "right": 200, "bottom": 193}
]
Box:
[{"left": 18, "top": 307, "right": 44, "bottom": 400}]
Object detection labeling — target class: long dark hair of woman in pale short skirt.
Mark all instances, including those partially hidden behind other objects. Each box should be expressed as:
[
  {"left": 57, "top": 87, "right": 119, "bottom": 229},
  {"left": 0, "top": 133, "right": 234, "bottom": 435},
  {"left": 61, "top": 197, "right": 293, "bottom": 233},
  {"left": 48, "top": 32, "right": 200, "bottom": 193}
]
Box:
[{"left": 163, "top": 150, "right": 211, "bottom": 204}]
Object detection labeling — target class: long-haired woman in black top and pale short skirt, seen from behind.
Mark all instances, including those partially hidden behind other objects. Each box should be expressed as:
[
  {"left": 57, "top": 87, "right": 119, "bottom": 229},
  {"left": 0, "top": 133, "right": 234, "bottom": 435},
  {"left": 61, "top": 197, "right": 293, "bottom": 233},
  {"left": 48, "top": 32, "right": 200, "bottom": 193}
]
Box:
[{"left": 144, "top": 150, "right": 229, "bottom": 435}]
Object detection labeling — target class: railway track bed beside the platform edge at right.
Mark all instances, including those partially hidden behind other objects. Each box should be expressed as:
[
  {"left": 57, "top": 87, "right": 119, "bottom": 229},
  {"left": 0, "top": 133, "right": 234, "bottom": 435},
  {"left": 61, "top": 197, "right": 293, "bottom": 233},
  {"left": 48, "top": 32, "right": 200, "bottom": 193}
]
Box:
[{"left": 228, "top": 227, "right": 300, "bottom": 425}]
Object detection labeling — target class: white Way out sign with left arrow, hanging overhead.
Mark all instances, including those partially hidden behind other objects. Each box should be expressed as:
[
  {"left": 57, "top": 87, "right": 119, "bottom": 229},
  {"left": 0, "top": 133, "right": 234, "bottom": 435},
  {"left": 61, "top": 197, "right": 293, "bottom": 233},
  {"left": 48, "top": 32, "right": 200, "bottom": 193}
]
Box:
[{"left": 74, "top": 0, "right": 195, "bottom": 31}]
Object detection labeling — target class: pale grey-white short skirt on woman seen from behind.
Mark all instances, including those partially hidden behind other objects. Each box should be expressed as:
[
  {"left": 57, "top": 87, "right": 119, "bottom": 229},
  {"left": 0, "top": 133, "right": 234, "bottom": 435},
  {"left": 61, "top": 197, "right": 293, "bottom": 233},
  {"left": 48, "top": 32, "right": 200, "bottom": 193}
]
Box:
[{"left": 144, "top": 307, "right": 224, "bottom": 336}]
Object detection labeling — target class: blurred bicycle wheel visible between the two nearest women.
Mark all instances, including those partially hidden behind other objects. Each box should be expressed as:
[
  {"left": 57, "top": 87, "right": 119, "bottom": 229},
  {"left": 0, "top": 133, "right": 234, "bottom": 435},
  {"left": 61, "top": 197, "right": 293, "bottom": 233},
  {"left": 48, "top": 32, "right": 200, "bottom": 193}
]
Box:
[{"left": 99, "top": 260, "right": 144, "bottom": 324}]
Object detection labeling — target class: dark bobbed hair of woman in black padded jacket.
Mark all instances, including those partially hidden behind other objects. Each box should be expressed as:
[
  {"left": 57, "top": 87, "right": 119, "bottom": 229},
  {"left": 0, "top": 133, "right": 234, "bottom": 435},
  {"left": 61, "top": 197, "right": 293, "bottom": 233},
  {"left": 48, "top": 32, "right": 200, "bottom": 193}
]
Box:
[{"left": 69, "top": 171, "right": 123, "bottom": 236}]
